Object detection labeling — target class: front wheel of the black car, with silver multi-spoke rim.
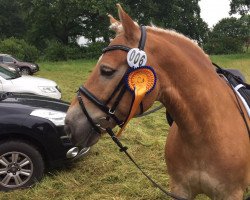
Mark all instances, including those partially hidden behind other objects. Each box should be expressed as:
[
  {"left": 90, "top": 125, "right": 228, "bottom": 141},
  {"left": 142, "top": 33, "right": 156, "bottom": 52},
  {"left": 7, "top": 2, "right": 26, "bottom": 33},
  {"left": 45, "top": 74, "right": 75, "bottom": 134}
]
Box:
[{"left": 0, "top": 140, "right": 44, "bottom": 191}]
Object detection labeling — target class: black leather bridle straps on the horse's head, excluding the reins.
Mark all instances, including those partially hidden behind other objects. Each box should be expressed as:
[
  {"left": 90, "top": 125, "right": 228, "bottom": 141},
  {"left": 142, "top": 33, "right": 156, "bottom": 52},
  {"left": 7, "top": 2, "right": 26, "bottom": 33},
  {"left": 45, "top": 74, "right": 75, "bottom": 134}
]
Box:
[{"left": 77, "top": 26, "right": 147, "bottom": 134}]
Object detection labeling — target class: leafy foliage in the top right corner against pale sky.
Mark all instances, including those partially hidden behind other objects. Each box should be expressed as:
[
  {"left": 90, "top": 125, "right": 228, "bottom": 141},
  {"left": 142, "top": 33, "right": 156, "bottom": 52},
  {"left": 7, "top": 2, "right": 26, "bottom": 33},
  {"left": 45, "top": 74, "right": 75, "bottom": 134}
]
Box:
[{"left": 229, "top": 0, "right": 250, "bottom": 15}]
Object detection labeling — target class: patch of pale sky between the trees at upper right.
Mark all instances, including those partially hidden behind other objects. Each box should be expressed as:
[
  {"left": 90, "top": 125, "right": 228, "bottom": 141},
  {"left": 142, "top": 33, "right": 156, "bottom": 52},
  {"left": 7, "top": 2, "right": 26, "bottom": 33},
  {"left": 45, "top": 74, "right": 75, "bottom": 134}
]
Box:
[{"left": 199, "top": 0, "right": 237, "bottom": 28}]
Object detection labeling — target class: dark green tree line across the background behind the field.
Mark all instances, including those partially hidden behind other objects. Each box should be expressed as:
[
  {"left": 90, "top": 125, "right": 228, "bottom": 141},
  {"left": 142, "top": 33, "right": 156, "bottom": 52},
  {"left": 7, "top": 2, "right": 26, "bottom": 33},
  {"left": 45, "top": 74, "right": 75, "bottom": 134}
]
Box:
[{"left": 0, "top": 0, "right": 250, "bottom": 60}]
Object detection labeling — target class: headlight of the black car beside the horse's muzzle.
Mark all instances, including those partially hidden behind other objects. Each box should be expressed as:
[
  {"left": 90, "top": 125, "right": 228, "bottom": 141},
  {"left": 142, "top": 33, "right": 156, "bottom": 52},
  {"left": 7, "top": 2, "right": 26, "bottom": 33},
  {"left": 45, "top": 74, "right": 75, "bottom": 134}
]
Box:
[{"left": 30, "top": 109, "right": 66, "bottom": 126}]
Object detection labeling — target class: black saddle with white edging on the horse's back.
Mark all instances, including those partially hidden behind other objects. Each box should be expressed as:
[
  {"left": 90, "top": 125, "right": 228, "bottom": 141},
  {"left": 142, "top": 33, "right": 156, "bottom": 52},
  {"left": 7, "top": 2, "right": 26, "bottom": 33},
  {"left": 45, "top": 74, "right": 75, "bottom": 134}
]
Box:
[{"left": 166, "top": 63, "right": 250, "bottom": 126}]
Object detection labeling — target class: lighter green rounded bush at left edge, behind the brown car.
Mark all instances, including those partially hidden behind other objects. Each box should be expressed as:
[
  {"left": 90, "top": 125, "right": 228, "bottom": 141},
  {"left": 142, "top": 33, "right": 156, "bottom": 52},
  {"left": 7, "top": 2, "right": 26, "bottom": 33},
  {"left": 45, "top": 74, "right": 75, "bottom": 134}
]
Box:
[{"left": 0, "top": 37, "right": 40, "bottom": 62}]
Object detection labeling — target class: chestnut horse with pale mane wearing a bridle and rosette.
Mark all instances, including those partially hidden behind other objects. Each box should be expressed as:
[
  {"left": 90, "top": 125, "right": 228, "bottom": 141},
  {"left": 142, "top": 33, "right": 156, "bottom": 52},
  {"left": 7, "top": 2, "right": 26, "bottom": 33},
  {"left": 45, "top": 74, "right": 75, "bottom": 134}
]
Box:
[{"left": 65, "top": 4, "right": 250, "bottom": 200}]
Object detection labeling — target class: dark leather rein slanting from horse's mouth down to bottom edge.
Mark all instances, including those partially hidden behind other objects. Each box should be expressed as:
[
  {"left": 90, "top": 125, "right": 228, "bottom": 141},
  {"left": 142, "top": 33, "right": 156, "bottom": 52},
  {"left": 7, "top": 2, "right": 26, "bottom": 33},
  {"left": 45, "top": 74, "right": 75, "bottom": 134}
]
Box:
[{"left": 106, "top": 128, "right": 187, "bottom": 200}]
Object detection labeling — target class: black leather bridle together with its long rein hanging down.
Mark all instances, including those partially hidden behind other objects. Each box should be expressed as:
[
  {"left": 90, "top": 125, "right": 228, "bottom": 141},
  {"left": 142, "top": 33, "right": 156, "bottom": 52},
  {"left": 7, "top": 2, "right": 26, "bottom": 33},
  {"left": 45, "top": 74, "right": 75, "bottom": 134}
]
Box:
[{"left": 77, "top": 26, "right": 187, "bottom": 200}]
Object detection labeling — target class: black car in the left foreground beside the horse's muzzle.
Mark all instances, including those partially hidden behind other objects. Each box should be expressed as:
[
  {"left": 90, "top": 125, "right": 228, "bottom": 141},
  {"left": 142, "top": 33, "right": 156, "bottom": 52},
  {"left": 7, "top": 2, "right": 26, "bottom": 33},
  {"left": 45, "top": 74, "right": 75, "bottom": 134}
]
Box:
[{"left": 0, "top": 93, "right": 89, "bottom": 190}]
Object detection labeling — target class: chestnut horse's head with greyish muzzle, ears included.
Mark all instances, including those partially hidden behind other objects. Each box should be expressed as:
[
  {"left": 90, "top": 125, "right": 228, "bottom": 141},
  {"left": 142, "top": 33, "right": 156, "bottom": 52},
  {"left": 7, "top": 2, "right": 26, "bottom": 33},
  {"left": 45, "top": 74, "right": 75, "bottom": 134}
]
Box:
[{"left": 65, "top": 4, "right": 158, "bottom": 146}]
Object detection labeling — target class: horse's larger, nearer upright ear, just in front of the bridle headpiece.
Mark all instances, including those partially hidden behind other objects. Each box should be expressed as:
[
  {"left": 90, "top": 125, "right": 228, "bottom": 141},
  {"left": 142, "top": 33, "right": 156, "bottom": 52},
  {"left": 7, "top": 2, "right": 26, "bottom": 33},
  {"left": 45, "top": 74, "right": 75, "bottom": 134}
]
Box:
[{"left": 116, "top": 4, "right": 140, "bottom": 39}]
